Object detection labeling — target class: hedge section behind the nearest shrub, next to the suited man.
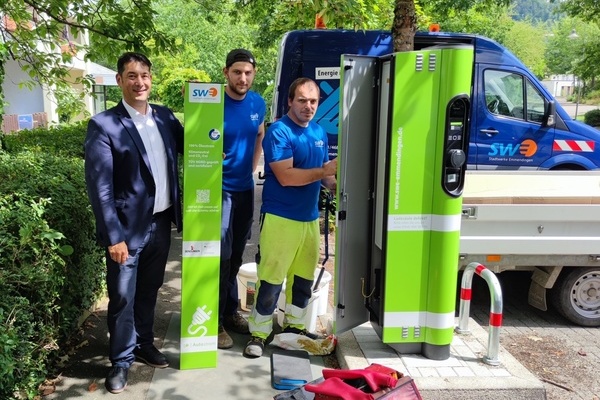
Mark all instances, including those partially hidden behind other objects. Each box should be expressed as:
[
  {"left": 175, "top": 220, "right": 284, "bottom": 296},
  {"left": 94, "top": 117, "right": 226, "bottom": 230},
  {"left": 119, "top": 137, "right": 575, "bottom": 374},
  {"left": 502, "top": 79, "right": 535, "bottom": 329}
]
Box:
[{"left": 0, "top": 152, "right": 104, "bottom": 336}]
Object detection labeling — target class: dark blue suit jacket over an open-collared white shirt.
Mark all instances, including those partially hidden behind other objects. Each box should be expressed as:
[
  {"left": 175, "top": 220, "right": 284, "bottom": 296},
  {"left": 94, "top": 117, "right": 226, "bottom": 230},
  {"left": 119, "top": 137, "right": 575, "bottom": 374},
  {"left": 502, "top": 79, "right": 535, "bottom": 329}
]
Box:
[{"left": 85, "top": 102, "right": 183, "bottom": 252}]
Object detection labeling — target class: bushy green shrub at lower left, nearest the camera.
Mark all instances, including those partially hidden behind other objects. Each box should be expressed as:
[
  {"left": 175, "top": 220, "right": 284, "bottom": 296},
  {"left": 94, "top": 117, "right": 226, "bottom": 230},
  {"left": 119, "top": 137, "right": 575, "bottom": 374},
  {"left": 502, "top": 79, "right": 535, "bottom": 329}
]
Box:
[{"left": 0, "top": 194, "right": 68, "bottom": 399}]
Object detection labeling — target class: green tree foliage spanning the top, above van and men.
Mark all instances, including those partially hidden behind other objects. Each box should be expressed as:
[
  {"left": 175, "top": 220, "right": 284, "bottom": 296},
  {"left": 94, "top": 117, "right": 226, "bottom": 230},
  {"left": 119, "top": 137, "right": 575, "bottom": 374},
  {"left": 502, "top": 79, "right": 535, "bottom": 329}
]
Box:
[{"left": 0, "top": 0, "right": 600, "bottom": 123}]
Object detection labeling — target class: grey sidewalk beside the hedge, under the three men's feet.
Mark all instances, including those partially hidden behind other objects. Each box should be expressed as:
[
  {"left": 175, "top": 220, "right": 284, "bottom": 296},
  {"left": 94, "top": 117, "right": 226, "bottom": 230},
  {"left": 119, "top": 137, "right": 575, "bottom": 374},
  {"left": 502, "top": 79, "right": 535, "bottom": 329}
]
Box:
[{"left": 45, "top": 225, "right": 324, "bottom": 400}]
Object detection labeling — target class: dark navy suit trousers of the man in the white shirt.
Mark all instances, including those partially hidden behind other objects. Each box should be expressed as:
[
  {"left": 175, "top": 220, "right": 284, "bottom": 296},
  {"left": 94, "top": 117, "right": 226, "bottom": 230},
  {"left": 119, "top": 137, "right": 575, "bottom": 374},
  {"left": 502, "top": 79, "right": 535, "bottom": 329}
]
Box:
[{"left": 106, "top": 211, "right": 171, "bottom": 368}]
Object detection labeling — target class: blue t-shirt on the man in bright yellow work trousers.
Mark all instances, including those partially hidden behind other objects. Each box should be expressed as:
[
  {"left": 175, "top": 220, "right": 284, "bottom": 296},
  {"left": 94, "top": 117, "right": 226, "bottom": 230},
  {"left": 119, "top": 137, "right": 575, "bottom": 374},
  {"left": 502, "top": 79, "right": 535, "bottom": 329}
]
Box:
[{"left": 261, "top": 115, "right": 329, "bottom": 222}]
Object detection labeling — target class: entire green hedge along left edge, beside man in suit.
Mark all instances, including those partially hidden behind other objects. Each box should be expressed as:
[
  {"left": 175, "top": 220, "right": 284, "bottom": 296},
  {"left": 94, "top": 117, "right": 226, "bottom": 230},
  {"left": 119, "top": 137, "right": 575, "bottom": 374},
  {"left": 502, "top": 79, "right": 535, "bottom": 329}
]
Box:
[{"left": 0, "top": 123, "right": 105, "bottom": 398}]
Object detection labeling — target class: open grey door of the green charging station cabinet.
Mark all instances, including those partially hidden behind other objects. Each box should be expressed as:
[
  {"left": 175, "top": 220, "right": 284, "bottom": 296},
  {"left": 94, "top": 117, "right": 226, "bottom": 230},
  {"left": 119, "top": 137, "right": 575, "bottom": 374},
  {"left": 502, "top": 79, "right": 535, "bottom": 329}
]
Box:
[{"left": 333, "top": 55, "right": 379, "bottom": 334}]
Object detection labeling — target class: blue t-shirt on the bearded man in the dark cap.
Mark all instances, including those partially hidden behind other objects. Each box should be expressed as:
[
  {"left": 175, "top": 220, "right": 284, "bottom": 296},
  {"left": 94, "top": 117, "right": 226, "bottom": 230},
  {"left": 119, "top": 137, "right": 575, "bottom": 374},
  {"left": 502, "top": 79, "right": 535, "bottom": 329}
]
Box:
[{"left": 223, "top": 91, "right": 266, "bottom": 192}]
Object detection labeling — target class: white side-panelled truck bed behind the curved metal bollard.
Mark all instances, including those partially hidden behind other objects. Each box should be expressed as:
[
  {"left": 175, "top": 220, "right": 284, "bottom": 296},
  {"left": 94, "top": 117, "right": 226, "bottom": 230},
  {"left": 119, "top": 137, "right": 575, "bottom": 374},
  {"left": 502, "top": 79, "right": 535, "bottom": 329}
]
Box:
[{"left": 460, "top": 171, "right": 600, "bottom": 256}]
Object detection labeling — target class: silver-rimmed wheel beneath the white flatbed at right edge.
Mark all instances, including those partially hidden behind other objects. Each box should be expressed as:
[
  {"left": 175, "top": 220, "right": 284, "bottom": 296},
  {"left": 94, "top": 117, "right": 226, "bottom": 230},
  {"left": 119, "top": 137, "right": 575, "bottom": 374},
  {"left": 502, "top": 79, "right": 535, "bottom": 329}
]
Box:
[{"left": 550, "top": 268, "right": 600, "bottom": 326}]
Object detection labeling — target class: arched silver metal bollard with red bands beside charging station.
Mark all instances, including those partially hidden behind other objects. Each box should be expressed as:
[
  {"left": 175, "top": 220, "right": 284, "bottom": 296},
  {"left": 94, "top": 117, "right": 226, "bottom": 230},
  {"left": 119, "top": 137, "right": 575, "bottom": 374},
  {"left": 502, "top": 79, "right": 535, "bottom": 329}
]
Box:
[{"left": 455, "top": 262, "right": 502, "bottom": 365}]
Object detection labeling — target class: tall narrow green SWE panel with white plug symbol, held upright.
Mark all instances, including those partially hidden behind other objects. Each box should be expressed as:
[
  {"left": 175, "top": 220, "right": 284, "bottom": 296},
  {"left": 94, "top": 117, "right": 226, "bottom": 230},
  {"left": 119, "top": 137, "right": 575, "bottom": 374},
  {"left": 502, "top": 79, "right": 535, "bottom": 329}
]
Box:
[{"left": 180, "top": 83, "right": 224, "bottom": 369}]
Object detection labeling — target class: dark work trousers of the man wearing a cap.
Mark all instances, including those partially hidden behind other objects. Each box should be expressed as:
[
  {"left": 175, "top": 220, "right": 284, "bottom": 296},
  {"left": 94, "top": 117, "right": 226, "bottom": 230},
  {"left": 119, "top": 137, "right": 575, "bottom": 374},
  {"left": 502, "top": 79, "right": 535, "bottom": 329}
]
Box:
[{"left": 219, "top": 189, "right": 254, "bottom": 324}]
